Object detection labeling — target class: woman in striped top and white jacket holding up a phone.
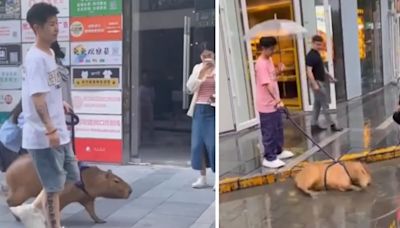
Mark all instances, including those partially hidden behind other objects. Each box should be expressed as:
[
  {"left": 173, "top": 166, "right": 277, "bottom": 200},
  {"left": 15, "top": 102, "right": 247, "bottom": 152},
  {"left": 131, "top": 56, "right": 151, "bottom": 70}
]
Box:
[{"left": 187, "top": 50, "right": 215, "bottom": 188}]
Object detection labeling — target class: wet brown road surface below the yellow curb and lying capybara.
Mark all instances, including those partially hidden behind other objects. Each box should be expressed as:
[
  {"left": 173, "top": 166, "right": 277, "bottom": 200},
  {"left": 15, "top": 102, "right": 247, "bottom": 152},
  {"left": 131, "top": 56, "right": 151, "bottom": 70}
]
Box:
[{"left": 220, "top": 159, "right": 400, "bottom": 228}]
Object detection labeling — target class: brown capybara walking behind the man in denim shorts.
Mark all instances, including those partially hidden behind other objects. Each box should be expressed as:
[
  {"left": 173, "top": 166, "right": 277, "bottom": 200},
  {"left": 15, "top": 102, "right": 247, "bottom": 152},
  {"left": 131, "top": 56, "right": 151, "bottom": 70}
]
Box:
[{"left": 6, "top": 155, "right": 132, "bottom": 223}]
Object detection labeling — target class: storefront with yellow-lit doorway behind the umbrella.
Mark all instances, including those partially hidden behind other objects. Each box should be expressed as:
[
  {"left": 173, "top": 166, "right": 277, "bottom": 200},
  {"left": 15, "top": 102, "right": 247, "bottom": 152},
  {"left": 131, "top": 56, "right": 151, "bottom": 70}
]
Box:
[{"left": 220, "top": 0, "right": 398, "bottom": 132}]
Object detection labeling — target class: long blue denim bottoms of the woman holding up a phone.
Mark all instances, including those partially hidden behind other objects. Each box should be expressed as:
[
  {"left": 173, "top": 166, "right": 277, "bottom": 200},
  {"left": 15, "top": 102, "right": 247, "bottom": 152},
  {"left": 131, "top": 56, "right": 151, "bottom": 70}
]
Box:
[{"left": 191, "top": 104, "right": 215, "bottom": 172}]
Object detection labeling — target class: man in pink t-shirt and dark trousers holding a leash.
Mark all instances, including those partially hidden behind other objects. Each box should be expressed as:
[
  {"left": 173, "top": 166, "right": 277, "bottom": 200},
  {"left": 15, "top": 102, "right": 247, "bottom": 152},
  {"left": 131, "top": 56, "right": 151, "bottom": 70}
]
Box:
[{"left": 255, "top": 37, "right": 294, "bottom": 168}]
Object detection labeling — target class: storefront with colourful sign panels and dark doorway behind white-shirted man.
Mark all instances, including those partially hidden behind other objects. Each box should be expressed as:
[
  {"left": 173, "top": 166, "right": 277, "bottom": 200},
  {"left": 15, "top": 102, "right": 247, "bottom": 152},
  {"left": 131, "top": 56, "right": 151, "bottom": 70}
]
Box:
[{"left": 0, "top": 0, "right": 215, "bottom": 165}]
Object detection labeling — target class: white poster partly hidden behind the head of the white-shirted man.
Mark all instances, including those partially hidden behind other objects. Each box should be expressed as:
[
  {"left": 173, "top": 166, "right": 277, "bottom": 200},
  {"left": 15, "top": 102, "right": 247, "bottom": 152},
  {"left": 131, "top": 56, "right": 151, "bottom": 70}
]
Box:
[{"left": 22, "top": 18, "right": 69, "bottom": 43}]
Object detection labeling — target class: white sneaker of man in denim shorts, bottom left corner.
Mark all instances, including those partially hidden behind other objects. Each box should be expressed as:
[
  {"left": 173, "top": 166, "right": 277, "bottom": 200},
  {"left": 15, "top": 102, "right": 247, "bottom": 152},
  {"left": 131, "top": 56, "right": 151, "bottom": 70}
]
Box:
[{"left": 10, "top": 204, "right": 46, "bottom": 228}]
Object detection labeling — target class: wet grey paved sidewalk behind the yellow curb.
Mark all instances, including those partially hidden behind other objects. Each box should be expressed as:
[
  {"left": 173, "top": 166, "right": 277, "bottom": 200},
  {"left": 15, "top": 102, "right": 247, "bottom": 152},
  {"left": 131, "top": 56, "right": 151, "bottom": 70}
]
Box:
[{"left": 220, "top": 86, "right": 400, "bottom": 179}]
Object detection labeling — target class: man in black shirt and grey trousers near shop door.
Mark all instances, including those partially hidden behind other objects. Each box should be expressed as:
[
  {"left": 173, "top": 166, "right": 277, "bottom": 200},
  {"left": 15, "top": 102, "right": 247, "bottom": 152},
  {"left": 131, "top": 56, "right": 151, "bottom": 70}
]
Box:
[{"left": 306, "top": 35, "right": 342, "bottom": 131}]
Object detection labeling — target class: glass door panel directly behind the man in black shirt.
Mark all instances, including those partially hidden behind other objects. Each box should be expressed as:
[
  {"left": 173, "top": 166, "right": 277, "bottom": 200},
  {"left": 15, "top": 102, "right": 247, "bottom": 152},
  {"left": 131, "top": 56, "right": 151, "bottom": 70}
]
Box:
[{"left": 300, "top": 0, "right": 336, "bottom": 111}]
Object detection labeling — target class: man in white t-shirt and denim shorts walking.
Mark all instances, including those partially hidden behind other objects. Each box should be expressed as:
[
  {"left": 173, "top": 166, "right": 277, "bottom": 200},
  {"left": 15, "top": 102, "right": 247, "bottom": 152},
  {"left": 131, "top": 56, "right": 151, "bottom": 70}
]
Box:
[{"left": 10, "top": 3, "right": 79, "bottom": 228}]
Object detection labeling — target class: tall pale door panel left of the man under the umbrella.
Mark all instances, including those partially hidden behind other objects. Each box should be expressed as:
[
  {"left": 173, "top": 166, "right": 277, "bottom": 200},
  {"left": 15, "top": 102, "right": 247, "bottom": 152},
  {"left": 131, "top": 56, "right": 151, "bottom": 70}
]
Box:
[{"left": 220, "top": 0, "right": 257, "bottom": 130}]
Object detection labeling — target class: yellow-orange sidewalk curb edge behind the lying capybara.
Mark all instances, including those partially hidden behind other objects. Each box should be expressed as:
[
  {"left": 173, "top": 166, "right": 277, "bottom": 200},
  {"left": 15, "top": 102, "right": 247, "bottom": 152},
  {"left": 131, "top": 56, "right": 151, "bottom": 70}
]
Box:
[{"left": 219, "top": 146, "right": 400, "bottom": 194}]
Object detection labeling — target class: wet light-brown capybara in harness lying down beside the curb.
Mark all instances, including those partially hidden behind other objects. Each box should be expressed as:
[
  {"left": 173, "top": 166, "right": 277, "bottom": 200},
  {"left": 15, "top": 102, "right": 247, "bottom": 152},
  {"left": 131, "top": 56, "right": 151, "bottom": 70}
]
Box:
[{"left": 294, "top": 161, "right": 371, "bottom": 197}]
